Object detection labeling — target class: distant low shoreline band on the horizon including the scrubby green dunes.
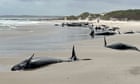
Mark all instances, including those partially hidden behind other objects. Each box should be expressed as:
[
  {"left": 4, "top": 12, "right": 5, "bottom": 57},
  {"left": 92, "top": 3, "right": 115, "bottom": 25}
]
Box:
[{"left": 0, "top": 9, "right": 140, "bottom": 21}]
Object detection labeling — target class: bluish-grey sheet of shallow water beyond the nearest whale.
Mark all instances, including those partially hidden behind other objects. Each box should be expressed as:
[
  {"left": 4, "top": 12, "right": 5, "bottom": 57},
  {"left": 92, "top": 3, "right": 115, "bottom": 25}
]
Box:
[{"left": 0, "top": 25, "right": 91, "bottom": 55}]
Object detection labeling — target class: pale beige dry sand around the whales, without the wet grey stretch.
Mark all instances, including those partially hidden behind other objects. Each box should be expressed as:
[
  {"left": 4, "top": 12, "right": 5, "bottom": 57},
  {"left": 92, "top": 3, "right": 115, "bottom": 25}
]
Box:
[{"left": 0, "top": 21, "right": 140, "bottom": 84}]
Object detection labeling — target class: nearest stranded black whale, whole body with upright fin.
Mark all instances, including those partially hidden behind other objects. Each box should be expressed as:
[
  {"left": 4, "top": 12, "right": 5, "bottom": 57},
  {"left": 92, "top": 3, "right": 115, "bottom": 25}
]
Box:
[{"left": 11, "top": 46, "right": 91, "bottom": 71}]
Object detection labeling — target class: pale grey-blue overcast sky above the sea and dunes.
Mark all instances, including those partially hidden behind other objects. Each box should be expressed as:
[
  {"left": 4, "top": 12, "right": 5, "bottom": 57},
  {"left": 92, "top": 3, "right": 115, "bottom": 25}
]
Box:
[{"left": 0, "top": 0, "right": 140, "bottom": 16}]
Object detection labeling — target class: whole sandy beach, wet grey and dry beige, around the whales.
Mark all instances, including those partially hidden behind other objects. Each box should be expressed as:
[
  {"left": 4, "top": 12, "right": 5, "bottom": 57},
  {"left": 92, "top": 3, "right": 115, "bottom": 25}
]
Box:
[{"left": 0, "top": 21, "right": 140, "bottom": 84}]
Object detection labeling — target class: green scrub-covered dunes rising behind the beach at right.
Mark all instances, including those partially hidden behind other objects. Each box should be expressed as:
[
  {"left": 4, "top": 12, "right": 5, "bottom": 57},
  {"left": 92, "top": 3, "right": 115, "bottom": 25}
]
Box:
[{"left": 67, "top": 9, "right": 140, "bottom": 20}]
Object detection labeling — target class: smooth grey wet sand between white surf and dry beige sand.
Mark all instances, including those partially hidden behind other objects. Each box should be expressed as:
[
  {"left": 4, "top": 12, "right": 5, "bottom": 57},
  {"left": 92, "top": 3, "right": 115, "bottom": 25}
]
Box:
[{"left": 0, "top": 23, "right": 91, "bottom": 55}]
